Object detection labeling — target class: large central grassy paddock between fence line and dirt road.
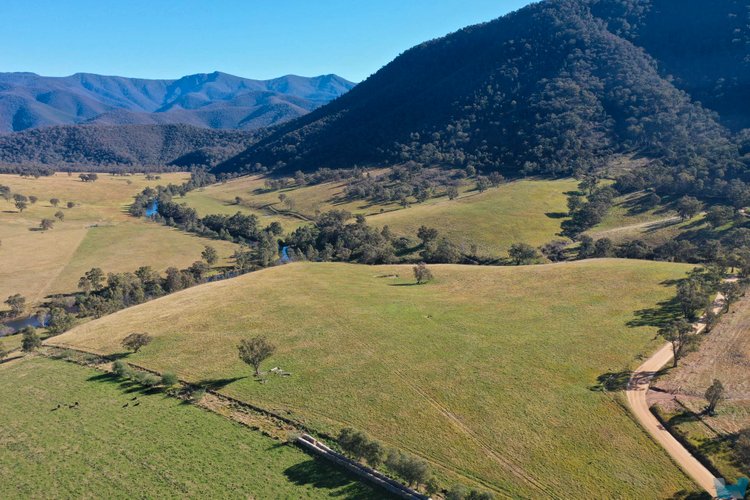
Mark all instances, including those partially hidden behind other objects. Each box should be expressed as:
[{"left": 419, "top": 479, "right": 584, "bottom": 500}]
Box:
[{"left": 49, "top": 260, "right": 691, "bottom": 498}]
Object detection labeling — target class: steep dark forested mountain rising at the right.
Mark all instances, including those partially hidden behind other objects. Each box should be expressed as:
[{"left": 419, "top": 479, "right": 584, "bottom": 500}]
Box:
[{"left": 217, "top": 0, "right": 750, "bottom": 202}]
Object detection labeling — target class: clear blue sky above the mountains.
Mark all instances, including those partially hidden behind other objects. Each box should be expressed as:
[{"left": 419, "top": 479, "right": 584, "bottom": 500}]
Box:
[{"left": 0, "top": 0, "right": 530, "bottom": 81}]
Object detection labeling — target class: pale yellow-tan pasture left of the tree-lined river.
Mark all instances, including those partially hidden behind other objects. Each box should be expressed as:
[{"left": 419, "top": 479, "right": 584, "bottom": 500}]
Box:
[{"left": 0, "top": 173, "right": 234, "bottom": 303}]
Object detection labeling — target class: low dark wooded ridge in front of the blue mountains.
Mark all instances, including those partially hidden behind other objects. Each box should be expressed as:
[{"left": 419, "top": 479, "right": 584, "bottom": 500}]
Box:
[{"left": 0, "top": 125, "right": 259, "bottom": 171}]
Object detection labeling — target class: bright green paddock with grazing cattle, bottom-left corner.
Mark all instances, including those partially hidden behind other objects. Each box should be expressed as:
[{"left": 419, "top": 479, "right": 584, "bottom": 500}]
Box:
[{"left": 0, "top": 358, "right": 382, "bottom": 499}]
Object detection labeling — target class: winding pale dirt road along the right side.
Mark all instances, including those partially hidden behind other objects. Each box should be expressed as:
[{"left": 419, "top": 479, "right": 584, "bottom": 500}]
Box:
[{"left": 626, "top": 286, "right": 724, "bottom": 496}]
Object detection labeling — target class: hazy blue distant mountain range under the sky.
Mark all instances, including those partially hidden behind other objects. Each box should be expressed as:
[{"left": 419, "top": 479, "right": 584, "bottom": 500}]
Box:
[{"left": 0, "top": 72, "right": 354, "bottom": 132}]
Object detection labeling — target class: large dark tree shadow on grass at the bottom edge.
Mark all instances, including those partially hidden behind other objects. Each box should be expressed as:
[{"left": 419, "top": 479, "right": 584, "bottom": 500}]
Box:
[{"left": 284, "top": 458, "right": 390, "bottom": 498}]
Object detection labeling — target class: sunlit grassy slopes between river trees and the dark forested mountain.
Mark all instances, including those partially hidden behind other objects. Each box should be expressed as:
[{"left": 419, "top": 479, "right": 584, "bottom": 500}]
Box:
[{"left": 179, "top": 176, "right": 577, "bottom": 256}]
